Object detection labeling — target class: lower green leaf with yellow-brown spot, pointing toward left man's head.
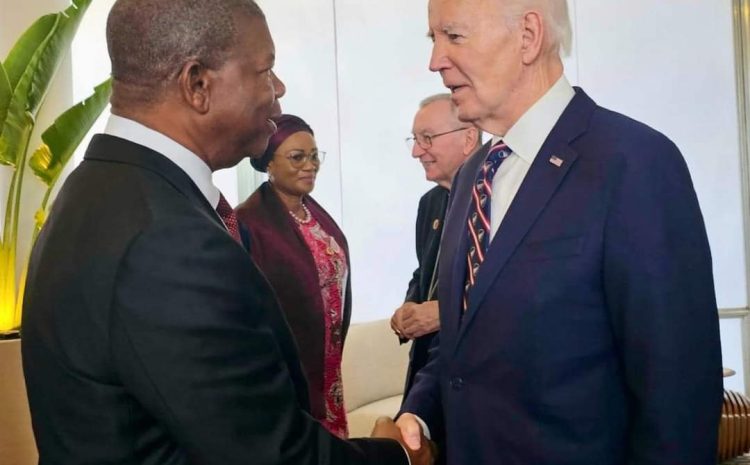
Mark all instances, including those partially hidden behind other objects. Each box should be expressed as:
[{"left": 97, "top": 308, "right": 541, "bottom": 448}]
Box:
[{"left": 29, "top": 79, "right": 112, "bottom": 187}]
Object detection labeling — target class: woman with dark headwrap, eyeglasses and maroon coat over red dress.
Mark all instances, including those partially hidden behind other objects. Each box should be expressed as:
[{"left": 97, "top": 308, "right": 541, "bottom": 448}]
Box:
[{"left": 237, "top": 115, "right": 351, "bottom": 438}]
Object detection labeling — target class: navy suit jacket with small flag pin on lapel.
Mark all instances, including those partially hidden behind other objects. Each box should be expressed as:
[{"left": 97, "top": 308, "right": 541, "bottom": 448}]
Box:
[{"left": 402, "top": 89, "right": 722, "bottom": 465}]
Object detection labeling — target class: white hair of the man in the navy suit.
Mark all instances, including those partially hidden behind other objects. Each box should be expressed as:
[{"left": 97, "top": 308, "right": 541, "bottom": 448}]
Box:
[{"left": 505, "top": 0, "right": 573, "bottom": 56}]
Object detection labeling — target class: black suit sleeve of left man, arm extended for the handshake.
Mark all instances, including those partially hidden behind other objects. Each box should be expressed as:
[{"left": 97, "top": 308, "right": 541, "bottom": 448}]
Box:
[{"left": 110, "top": 219, "right": 407, "bottom": 465}]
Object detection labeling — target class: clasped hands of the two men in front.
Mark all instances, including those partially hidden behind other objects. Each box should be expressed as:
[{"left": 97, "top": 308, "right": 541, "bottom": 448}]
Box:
[{"left": 371, "top": 413, "right": 437, "bottom": 465}]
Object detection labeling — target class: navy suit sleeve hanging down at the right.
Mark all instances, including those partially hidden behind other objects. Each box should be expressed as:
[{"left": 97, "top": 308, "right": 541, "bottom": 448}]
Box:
[{"left": 603, "top": 138, "right": 722, "bottom": 465}]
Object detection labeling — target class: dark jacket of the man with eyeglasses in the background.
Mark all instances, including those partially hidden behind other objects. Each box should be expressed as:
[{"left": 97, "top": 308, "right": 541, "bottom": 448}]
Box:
[{"left": 404, "top": 186, "right": 450, "bottom": 395}]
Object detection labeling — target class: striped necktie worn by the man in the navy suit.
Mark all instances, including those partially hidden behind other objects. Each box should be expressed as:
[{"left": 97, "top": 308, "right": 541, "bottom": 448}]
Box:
[{"left": 463, "top": 140, "right": 512, "bottom": 311}]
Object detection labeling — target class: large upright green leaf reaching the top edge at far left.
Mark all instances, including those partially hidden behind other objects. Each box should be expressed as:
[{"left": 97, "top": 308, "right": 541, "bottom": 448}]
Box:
[{"left": 0, "top": 0, "right": 92, "bottom": 166}]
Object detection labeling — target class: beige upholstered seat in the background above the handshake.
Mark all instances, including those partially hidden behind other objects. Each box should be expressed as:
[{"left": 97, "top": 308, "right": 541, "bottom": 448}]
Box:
[{"left": 342, "top": 320, "right": 411, "bottom": 437}]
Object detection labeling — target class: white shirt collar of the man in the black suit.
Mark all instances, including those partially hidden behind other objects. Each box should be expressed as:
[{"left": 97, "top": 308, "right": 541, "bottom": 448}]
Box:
[{"left": 104, "top": 115, "right": 220, "bottom": 208}]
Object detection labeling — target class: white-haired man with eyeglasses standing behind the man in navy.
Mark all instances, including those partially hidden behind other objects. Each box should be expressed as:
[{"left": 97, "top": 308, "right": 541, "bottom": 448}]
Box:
[{"left": 391, "top": 93, "right": 482, "bottom": 402}]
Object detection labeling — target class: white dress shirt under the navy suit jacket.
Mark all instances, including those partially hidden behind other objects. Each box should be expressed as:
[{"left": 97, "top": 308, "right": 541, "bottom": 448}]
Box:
[{"left": 490, "top": 75, "right": 575, "bottom": 241}]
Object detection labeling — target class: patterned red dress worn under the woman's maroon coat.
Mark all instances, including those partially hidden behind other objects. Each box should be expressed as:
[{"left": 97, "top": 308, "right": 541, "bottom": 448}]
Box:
[{"left": 293, "top": 209, "right": 349, "bottom": 438}]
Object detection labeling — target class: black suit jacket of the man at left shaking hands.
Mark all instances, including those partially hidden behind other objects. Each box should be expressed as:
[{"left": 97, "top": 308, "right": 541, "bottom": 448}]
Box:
[{"left": 22, "top": 135, "right": 406, "bottom": 465}]
